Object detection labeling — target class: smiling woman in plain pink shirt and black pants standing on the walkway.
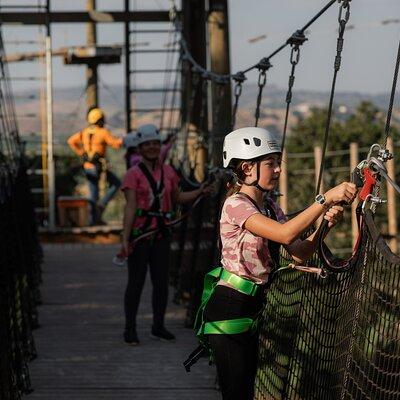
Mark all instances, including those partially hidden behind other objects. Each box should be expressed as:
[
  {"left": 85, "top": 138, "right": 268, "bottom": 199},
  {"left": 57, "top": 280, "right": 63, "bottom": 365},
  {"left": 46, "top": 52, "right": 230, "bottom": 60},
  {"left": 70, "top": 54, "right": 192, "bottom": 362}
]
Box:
[{"left": 122, "top": 124, "right": 211, "bottom": 345}]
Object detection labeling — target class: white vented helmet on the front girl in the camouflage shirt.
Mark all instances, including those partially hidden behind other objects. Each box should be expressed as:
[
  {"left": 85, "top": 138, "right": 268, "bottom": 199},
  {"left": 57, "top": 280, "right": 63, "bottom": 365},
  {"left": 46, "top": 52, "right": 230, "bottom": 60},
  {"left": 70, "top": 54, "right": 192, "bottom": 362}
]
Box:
[{"left": 222, "top": 127, "right": 282, "bottom": 168}]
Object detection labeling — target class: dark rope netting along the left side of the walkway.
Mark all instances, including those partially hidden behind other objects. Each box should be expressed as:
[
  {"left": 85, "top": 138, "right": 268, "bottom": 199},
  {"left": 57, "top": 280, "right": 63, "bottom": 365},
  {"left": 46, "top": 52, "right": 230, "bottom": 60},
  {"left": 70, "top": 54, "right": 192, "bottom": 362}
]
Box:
[{"left": 0, "top": 28, "right": 41, "bottom": 400}]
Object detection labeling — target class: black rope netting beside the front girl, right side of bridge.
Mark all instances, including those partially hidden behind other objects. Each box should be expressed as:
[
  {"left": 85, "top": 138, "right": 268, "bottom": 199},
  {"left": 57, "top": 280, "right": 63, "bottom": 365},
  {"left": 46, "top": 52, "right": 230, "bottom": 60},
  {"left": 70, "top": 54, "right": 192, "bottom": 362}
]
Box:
[{"left": 255, "top": 211, "right": 400, "bottom": 400}]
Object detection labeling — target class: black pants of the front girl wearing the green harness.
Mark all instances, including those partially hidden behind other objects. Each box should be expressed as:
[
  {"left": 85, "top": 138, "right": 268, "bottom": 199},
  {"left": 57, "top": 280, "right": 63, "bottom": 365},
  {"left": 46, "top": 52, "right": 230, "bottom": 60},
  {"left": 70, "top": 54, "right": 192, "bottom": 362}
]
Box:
[{"left": 204, "top": 285, "right": 263, "bottom": 400}]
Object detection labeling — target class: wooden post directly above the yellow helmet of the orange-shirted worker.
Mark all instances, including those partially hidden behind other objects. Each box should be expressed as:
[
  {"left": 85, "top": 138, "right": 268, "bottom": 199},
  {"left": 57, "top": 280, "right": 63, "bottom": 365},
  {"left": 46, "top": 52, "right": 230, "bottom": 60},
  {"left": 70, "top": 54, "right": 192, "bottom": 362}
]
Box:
[{"left": 86, "top": 0, "right": 98, "bottom": 109}]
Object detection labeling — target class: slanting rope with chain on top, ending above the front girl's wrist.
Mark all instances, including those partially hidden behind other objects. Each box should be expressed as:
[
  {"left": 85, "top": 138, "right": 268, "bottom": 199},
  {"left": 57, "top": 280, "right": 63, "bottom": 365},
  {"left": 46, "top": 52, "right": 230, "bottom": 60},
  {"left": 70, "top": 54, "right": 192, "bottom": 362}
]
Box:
[{"left": 315, "top": 0, "right": 351, "bottom": 194}]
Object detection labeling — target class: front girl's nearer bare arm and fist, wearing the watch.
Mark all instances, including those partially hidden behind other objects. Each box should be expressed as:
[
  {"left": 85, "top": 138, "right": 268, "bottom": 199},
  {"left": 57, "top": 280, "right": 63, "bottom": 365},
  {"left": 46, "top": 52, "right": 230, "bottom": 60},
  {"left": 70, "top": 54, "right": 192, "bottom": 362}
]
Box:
[{"left": 244, "top": 182, "right": 357, "bottom": 245}]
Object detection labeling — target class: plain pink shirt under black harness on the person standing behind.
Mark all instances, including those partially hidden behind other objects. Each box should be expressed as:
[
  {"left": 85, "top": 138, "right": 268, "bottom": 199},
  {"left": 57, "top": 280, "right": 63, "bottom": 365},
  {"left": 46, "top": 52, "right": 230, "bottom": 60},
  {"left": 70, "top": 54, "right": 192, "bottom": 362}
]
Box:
[{"left": 121, "top": 164, "right": 179, "bottom": 228}]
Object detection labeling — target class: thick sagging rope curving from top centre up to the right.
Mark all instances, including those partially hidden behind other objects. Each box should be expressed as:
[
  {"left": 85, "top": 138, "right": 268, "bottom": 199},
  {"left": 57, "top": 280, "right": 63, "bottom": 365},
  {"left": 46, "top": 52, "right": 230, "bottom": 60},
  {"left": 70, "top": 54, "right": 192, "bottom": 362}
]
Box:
[{"left": 170, "top": 0, "right": 338, "bottom": 81}]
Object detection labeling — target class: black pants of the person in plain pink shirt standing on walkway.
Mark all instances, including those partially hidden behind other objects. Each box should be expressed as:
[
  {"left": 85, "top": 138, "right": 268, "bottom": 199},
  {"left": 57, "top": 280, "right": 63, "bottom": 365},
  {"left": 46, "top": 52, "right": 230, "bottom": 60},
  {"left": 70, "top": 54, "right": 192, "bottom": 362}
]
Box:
[{"left": 125, "top": 237, "right": 170, "bottom": 328}]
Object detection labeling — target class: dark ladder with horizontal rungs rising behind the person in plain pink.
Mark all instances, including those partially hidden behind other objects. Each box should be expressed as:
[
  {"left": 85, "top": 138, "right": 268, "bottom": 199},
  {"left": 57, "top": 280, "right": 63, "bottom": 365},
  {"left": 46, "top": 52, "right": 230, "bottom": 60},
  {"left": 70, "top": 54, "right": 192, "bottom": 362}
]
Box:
[{"left": 125, "top": 0, "right": 181, "bottom": 136}]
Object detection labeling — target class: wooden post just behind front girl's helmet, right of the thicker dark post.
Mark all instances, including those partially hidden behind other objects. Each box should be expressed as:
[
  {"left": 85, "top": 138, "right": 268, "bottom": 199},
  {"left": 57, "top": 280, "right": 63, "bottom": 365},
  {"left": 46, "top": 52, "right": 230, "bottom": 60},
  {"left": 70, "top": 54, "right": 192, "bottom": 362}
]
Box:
[{"left": 208, "top": 0, "right": 232, "bottom": 165}]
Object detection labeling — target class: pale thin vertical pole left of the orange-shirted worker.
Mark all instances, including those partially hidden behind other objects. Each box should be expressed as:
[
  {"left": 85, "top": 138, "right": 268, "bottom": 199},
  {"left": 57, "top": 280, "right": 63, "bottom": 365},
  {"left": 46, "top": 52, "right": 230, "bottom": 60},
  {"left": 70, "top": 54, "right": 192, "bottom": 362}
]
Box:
[{"left": 43, "top": 0, "right": 56, "bottom": 231}]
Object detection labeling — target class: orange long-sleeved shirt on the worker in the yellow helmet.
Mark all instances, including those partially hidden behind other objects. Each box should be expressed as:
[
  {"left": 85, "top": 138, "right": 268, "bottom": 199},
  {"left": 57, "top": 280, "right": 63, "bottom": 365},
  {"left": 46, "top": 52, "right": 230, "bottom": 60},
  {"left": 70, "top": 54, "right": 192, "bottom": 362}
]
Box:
[{"left": 68, "top": 125, "right": 122, "bottom": 169}]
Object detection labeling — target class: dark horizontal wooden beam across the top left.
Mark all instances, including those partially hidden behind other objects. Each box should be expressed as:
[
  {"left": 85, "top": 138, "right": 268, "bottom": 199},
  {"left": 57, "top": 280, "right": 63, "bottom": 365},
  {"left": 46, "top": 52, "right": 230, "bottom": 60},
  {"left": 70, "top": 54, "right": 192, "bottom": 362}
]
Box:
[{"left": 1, "top": 11, "right": 169, "bottom": 25}]
